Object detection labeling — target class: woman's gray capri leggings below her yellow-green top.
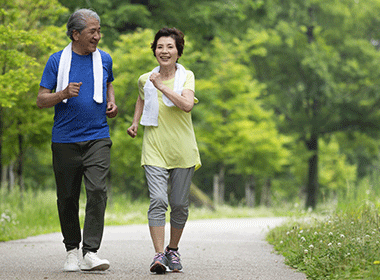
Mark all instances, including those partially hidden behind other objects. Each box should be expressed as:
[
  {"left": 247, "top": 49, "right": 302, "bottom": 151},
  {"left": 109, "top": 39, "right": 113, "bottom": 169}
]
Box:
[{"left": 144, "top": 165, "right": 195, "bottom": 229}]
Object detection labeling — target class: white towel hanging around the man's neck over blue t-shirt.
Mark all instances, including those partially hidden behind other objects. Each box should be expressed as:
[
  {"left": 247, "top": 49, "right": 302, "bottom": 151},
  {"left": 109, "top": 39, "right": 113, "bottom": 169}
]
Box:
[{"left": 56, "top": 42, "right": 103, "bottom": 103}]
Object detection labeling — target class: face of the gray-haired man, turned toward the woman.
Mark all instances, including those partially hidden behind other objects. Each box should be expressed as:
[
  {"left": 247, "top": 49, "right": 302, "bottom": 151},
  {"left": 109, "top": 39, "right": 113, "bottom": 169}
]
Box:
[{"left": 73, "top": 18, "right": 102, "bottom": 55}]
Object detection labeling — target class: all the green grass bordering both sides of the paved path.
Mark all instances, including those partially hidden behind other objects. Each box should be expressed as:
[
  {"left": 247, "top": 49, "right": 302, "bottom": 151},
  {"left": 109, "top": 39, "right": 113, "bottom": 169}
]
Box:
[{"left": 4, "top": 185, "right": 380, "bottom": 280}]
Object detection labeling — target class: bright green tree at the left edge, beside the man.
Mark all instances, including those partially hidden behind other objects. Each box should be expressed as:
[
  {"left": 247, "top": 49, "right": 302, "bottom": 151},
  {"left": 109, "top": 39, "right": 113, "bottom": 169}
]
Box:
[{"left": 0, "top": 0, "right": 66, "bottom": 187}]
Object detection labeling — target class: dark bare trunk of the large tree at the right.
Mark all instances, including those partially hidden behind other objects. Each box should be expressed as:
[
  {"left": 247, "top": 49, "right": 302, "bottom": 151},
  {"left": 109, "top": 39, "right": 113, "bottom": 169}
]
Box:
[{"left": 306, "top": 134, "right": 318, "bottom": 209}]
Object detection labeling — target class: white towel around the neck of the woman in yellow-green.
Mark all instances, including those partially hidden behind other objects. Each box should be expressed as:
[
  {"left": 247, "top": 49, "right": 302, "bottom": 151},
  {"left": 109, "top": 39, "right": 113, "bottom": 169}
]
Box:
[{"left": 140, "top": 63, "right": 187, "bottom": 126}]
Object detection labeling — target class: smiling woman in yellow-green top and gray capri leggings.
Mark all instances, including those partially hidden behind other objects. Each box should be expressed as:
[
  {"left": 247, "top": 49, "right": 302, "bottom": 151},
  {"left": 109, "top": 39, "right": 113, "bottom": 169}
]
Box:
[{"left": 128, "top": 28, "right": 201, "bottom": 273}]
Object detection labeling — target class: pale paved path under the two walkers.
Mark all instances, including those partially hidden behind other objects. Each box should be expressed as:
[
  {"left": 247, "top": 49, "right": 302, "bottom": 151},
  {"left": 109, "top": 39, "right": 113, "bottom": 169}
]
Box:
[{"left": 0, "top": 218, "right": 306, "bottom": 280}]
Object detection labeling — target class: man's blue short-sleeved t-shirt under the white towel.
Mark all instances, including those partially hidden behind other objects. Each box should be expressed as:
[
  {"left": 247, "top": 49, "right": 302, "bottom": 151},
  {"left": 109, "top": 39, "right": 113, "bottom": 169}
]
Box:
[{"left": 40, "top": 50, "right": 114, "bottom": 143}]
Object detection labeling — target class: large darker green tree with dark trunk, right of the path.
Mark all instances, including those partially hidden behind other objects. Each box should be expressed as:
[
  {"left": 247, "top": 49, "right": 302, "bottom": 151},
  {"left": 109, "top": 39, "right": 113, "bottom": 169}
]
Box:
[{"left": 251, "top": 0, "right": 380, "bottom": 208}]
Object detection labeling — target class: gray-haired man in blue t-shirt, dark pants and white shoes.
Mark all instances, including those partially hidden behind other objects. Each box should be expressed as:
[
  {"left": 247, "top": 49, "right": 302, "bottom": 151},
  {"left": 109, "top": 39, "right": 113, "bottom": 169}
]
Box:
[{"left": 37, "top": 9, "right": 117, "bottom": 271}]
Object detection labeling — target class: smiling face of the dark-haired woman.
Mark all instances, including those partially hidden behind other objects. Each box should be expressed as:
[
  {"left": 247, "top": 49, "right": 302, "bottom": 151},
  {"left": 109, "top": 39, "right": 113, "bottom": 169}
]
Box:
[{"left": 155, "top": 37, "right": 179, "bottom": 66}]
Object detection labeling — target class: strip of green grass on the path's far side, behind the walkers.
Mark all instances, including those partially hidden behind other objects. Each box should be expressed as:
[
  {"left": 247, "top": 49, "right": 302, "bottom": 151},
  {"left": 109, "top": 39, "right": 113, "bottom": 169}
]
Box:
[{"left": 0, "top": 188, "right": 282, "bottom": 241}]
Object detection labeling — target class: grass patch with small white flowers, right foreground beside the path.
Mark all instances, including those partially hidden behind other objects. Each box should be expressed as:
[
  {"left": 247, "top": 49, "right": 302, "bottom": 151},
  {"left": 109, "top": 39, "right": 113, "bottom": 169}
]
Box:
[{"left": 267, "top": 203, "right": 380, "bottom": 280}]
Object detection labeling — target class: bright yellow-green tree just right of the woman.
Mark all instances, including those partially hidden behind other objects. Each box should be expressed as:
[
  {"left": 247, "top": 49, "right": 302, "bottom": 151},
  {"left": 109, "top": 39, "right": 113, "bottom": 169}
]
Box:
[{"left": 195, "top": 34, "right": 287, "bottom": 203}]
